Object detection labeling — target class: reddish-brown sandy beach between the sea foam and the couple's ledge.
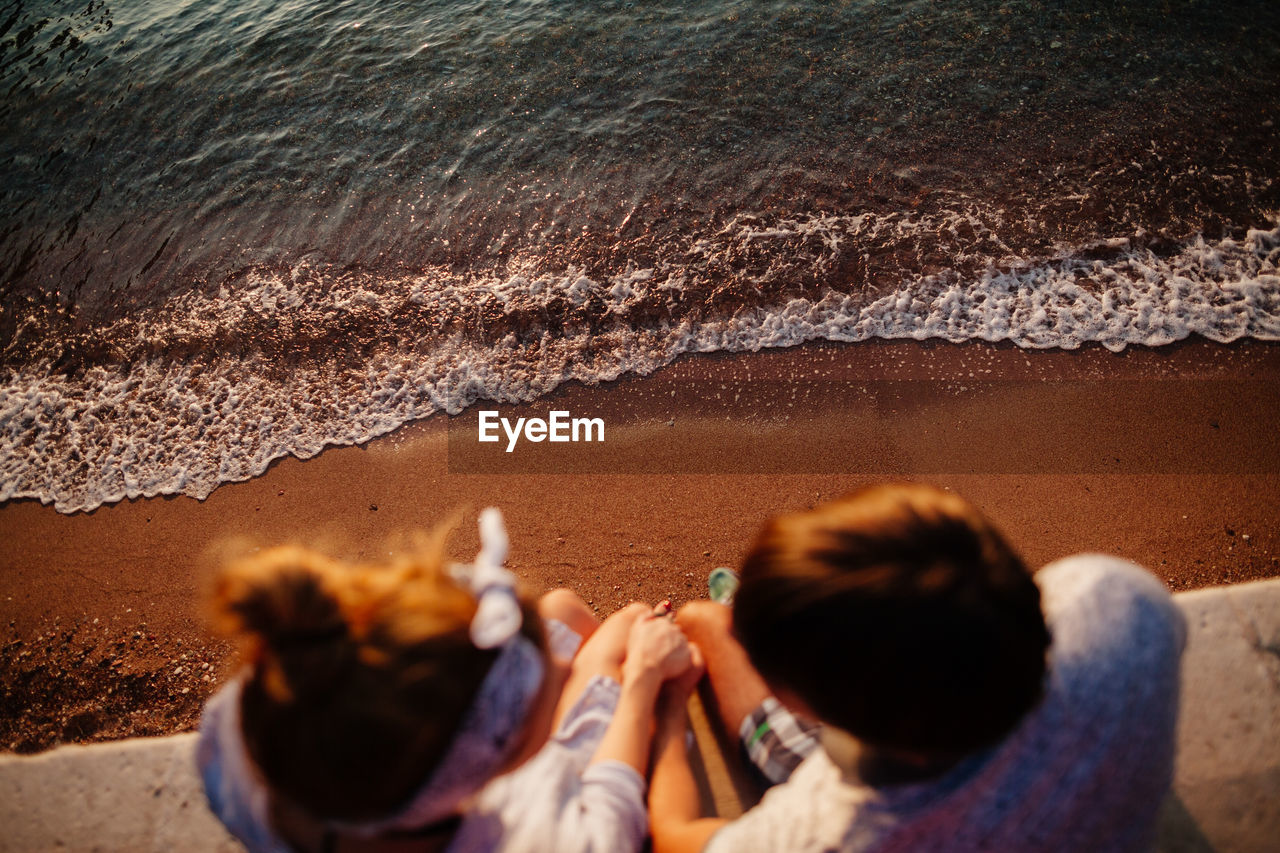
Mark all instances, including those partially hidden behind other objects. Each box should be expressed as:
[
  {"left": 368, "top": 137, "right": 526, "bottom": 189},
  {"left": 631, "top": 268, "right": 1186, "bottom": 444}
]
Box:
[{"left": 0, "top": 339, "right": 1280, "bottom": 752}]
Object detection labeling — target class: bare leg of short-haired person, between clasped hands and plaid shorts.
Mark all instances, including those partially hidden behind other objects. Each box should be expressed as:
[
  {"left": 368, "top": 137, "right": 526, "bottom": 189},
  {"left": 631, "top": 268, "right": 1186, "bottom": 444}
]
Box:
[{"left": 676, "top": 601, "right": 772, "bottom": 736}]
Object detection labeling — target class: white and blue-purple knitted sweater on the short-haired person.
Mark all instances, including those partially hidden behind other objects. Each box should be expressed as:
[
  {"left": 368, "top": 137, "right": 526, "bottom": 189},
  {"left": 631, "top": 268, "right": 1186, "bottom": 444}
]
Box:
[{"left": 705, "top": 555, "right": 1185, "bottom": 853}]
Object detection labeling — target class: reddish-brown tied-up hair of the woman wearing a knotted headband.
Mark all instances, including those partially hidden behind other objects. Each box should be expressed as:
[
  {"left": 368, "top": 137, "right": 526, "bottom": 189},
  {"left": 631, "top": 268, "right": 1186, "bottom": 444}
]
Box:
[{"left": 211, "top": 534, "right": 543, "bottom": 821}]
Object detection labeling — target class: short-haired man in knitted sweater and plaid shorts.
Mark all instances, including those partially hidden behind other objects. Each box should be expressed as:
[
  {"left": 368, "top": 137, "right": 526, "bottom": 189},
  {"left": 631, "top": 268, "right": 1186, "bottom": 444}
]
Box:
[{"left": 649, "top": 485, "right": 1185, "bottom": 853}]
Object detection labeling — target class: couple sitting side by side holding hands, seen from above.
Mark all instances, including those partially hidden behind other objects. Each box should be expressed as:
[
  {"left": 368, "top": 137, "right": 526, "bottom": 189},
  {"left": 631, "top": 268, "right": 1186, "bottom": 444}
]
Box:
[{"left": 197, "top": 485, "right": 1184, "bottom": 853}]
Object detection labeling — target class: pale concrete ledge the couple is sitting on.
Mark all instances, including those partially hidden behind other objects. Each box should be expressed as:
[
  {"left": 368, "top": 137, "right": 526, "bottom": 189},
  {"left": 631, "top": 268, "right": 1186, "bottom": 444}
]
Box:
[{"left": 0, "top": 579, "right": 1280, "bottom": 853}]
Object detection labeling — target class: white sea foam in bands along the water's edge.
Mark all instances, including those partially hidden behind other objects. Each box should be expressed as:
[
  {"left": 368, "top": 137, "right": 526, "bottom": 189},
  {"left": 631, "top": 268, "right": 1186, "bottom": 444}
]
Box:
[{"left": 0, "top": 215, "right": 1280, "bottom": 512}]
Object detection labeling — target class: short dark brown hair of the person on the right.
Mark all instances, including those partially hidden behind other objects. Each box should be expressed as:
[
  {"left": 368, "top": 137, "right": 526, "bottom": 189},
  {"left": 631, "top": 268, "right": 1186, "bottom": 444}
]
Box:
[{"left": 733, "top": 484, "right": 1050, "bottom": 757}]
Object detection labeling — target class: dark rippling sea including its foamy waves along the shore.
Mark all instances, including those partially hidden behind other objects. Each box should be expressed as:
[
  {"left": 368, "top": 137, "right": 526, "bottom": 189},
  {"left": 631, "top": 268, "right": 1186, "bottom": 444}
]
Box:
[{"left": 0, "top": 0, "right": 1280, "bottom": 511}]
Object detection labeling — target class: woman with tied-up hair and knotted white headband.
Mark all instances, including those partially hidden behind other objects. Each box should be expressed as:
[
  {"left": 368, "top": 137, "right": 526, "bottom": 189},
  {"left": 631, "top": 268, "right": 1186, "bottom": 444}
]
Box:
[{"left": 197, "top": 510, "right": 694, "bottom": 853}]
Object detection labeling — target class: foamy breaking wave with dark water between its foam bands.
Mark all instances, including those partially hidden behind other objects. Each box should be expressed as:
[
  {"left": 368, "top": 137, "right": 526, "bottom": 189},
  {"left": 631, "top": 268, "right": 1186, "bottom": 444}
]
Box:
[{"left": 0, "top": 214, "right": 1280, "bottom": 512}]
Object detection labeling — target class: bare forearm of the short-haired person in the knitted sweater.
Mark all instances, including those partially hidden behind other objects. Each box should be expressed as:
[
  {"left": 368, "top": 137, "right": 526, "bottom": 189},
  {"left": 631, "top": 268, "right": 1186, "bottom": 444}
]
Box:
[{"left": 649, "top": 667, "right": 728, "bottom": 853}]
